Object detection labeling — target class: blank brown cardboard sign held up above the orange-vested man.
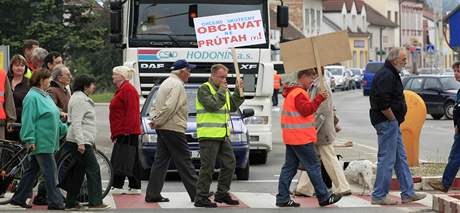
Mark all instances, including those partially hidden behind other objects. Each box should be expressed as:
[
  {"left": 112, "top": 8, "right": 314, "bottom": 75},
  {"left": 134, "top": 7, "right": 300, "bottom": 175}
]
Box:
[{"left": 280, "top": 31, "right": 351, "bottom": 73}]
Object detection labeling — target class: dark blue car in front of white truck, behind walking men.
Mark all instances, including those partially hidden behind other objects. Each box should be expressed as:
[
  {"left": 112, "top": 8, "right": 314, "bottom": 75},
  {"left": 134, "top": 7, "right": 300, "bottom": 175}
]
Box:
[{"left": 139, "top": 85, "right": 254, "bottom": 180}]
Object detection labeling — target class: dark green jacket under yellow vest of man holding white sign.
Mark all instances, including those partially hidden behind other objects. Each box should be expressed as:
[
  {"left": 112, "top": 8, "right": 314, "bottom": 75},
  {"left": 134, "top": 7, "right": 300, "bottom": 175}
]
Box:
[{"left": 197, "top": 79, "right": 244, "bottom": 140}]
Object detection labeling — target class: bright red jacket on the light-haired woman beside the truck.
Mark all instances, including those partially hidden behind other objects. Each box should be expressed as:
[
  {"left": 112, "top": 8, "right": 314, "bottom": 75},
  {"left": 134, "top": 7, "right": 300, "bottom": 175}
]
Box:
[{"left": 109, "top": 81, "right": 141, "bottom": 140}]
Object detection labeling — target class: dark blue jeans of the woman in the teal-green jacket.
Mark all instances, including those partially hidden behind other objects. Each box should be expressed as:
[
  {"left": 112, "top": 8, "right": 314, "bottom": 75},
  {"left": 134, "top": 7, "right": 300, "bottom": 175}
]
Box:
[{"left": 12, "top": 154, "right": 64, "bottom": 207}]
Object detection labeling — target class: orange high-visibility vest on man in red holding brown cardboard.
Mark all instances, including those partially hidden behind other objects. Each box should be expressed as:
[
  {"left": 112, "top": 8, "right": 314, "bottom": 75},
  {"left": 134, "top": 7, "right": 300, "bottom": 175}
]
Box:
[{"left": 281, "top": 88, "right": 316, "bottom": 145}]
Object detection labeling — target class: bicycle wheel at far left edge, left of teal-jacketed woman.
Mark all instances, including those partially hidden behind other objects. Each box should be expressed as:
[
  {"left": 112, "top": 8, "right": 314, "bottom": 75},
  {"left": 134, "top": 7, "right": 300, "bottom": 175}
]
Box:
[{"left": 0, "top": 144, "right": 25, "bottom": 205}]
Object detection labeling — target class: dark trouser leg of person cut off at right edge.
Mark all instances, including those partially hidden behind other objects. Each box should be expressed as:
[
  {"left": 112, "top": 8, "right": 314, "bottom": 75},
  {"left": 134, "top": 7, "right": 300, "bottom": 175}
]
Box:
[{"left": 442, "top": 133, "right": 460, "bottom": 189}]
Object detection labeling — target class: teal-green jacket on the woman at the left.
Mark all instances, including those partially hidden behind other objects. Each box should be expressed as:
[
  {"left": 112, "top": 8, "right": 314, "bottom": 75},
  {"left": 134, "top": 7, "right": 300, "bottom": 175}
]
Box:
[{"left": 20, "top": 87, "right": 67, "bottom": 154}]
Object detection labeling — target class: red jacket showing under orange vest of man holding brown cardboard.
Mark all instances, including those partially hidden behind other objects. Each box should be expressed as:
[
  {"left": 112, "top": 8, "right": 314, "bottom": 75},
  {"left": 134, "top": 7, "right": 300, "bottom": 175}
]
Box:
[{"left": 283, "top": 84, "right": 324, "bottom": 117}]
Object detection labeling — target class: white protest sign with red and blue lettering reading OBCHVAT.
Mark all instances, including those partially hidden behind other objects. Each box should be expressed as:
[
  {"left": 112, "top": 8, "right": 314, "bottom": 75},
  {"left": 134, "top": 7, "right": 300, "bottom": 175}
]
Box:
[{"left": 193, "top": 10, "right": 266, "bottom": 48}]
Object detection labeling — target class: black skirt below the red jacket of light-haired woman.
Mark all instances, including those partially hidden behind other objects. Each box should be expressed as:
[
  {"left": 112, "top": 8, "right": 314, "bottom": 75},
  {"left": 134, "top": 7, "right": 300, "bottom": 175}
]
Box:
[{"left": 110, "top": 136, "right": 137, "bottom": 177}]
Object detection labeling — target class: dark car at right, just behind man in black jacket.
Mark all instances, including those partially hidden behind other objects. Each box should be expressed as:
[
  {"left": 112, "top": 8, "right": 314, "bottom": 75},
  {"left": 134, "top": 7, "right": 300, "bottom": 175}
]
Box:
[{"left": 403, "top": 75, "right": 460, "bottom": 120}]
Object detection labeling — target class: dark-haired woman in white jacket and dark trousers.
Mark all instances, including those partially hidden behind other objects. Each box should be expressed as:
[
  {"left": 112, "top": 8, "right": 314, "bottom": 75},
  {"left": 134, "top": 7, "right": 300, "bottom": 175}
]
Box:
[{"left": 66, "top": 75, "right": 109, "bottom": 210}]
